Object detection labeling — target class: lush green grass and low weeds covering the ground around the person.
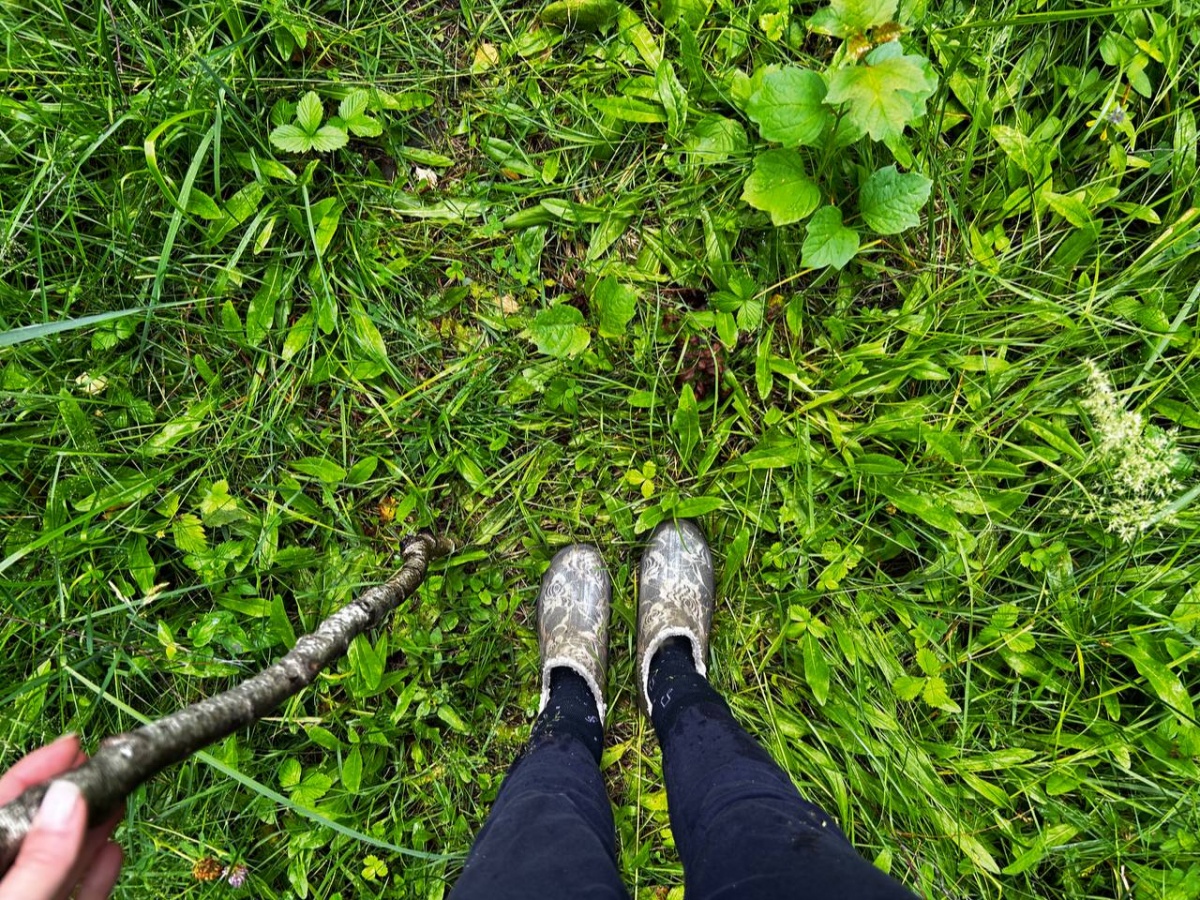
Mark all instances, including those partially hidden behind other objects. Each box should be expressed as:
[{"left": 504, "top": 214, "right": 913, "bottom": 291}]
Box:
[{"left": 0, "top": 0, "right": 1200, "bottom": 900}]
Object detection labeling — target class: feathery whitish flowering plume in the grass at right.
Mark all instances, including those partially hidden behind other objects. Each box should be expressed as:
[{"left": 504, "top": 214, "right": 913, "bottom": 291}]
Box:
[{"left": 1081, "top": 360, "right": 1184, "bottom": 542}]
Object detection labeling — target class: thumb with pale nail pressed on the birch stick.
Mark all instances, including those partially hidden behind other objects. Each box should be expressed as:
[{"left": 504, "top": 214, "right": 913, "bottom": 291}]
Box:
[{"left": 0, "top": 780, "right": 88, "bottom": 900}]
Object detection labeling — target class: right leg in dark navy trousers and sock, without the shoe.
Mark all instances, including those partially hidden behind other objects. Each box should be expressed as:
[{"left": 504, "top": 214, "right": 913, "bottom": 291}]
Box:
[{"left": 649, "top": 637, "right": 913, "bottom": 900}]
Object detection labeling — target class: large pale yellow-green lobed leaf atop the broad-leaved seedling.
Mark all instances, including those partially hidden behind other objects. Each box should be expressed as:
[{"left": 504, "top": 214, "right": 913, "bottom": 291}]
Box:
[{"left": 824, "top": 44, "right": 937, "bottom": 140}]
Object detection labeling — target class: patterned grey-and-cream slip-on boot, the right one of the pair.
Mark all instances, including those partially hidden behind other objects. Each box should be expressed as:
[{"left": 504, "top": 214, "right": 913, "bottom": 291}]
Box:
[{"left": 636, "top": 520, "right": 715, "bottom": 715}]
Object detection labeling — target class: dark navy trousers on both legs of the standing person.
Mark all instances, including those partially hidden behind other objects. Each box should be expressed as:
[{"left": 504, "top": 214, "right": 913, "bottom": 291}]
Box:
[{"left": 451, "top": 694, "right": 913, "bottom": 900}]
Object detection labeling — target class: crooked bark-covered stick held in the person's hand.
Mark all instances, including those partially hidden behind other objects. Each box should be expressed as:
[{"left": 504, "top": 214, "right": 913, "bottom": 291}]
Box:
[{"left": 0, "top": 534, "right": 454, "bottom": 877}]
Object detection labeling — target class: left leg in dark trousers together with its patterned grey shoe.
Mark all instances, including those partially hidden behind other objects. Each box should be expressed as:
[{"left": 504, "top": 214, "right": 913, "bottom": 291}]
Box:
[{"left": 451, "top": 545, "right": 629, "bottom": 900}]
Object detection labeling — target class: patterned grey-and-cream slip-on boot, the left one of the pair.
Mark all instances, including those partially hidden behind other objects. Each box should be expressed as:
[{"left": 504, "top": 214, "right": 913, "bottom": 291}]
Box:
[{"left": 538, "top": 544, "right": 612, "bottom": 722}]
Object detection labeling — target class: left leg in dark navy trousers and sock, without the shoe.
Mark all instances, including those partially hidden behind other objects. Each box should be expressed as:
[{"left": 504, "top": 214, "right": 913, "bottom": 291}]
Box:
[{"left": 450, "top": 668, "right": 628, "bottom": 900}]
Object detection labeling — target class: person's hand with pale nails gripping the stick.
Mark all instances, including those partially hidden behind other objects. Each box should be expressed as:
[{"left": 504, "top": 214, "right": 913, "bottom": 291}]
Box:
[{"left": 0, "top": 734, "right": 122, "bottom": 900}]
